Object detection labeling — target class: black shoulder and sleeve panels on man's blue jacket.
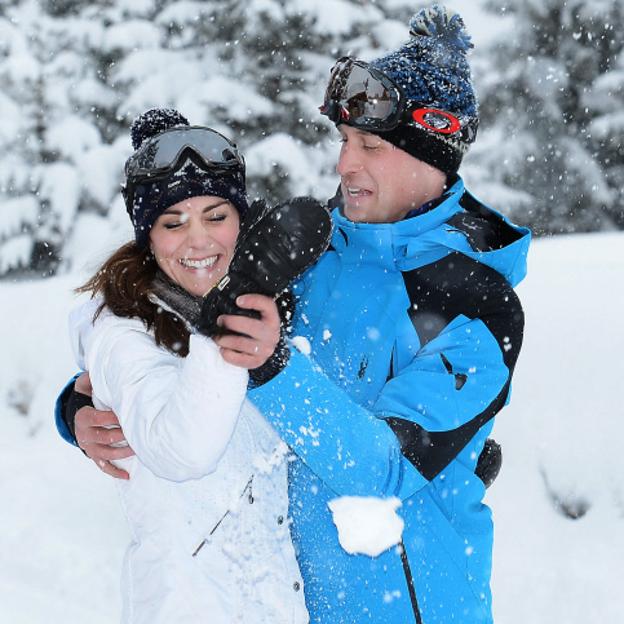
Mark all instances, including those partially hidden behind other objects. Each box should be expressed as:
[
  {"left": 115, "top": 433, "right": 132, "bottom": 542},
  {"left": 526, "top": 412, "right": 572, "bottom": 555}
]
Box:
[{"left": 386, "top": 252, "right": 524, "bottom": 480}]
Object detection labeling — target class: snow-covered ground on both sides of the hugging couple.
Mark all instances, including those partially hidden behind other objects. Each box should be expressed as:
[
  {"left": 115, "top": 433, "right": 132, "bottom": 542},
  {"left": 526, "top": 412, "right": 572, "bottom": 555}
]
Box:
[{"left": 0, "top": 234, "right": 624, "bottom": 624}]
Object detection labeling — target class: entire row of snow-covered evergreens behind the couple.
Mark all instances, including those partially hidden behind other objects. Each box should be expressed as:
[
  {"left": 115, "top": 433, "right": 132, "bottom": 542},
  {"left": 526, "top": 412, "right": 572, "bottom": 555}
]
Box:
[{"left": 0, "top": 0, "right": 624, "bottom": 278}]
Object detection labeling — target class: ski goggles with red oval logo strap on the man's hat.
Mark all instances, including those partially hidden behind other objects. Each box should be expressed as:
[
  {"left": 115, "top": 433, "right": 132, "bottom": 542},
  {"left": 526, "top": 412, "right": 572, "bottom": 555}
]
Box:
[{"left": 320, "top": 57, "right": 476, "bottom": 143}]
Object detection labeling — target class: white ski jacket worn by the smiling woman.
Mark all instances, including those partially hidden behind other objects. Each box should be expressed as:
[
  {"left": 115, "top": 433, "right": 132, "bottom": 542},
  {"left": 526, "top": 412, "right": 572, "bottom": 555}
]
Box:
[{"left": 70, "top": 299, "right": 308, "bottom": 624}]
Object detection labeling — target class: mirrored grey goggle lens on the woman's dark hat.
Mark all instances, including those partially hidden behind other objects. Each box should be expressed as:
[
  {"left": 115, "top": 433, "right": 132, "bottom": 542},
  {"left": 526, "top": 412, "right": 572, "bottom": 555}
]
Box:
[{"left": 127, "top": 128, "right": 242, "bottom": 175}]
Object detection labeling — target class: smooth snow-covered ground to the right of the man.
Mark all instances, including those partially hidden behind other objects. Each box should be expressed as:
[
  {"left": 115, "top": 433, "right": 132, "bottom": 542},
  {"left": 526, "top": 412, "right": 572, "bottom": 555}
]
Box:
[{"left": 488, "top": 234, "right": 624, "bottom": 624}]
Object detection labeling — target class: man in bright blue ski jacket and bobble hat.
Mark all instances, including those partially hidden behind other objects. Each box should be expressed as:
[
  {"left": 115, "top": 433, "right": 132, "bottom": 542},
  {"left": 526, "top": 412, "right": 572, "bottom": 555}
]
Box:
[{"left": 56, "top": 5, "right": 530, "bottom": 624}]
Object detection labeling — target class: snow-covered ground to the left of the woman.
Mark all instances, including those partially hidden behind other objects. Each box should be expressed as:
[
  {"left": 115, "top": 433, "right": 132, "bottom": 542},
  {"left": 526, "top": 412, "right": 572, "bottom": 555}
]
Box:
[{"left": 0, "top": 275, "right": 126, "bottom": 624}]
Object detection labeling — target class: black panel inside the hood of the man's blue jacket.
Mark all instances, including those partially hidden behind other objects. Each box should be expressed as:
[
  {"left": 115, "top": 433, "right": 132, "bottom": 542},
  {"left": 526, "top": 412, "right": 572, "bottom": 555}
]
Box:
[{"left": 447, "top": 193, "right": 522, "bottom": 251}]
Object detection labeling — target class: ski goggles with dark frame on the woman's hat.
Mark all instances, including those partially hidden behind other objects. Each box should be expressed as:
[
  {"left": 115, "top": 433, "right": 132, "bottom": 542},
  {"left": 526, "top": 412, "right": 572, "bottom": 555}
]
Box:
[{"left": 122, "top": 126, "right": 245, "bottom": 210}]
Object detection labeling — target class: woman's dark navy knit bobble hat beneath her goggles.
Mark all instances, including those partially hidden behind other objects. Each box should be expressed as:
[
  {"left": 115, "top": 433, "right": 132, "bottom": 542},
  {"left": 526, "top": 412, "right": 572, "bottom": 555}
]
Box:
[{"left": 128, "top": 108, "right": 248, "bottom": 248}]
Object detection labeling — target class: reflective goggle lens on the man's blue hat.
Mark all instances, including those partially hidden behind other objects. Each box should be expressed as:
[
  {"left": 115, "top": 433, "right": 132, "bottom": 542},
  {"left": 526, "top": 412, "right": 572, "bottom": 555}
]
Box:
[{"left": 323, "top": 64, "right": 398, "bottom": 126}]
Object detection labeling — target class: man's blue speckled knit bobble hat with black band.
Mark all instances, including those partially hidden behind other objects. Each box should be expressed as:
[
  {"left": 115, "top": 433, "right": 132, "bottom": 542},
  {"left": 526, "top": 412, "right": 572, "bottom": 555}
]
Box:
[{"left": 370, "top": 4, "right": 479, "bottom": 175}]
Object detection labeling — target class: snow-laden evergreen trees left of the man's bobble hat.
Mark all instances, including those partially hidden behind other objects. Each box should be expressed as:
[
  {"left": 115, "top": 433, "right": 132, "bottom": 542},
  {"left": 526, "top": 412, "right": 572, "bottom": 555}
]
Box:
[{"left": 0, "top": 0, "right": 436, "bottom": 277}]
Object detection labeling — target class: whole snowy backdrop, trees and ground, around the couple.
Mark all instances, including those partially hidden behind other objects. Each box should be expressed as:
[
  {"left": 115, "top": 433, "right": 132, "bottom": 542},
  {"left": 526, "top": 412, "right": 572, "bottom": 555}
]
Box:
[{"left": 0, "top": 0, "right": 624, "bottom": 624}]
